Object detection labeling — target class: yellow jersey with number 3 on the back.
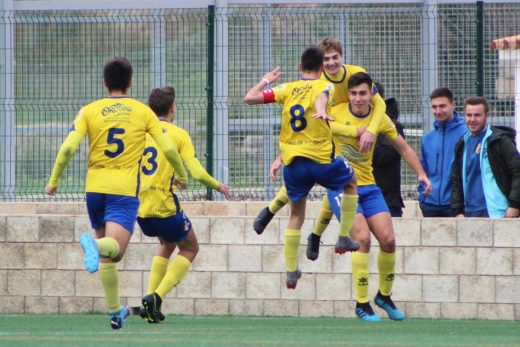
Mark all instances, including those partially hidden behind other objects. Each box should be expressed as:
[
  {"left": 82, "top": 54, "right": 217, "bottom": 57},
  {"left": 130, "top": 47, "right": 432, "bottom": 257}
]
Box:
[{"left": 137, "top": 121, "right": 195, "bottom": 218}]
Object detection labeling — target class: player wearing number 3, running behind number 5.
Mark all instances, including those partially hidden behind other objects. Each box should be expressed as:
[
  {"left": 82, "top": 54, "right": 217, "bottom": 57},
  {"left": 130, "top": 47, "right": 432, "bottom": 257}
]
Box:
[{"left": 137, "top": 86, "right": 230, "bottom": 323}]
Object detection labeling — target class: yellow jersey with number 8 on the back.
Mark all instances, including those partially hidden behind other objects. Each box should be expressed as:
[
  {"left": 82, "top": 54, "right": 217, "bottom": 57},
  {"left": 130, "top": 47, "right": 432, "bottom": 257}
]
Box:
[{"left": 272, "top": 79, "right": 334, "bottom": 165}]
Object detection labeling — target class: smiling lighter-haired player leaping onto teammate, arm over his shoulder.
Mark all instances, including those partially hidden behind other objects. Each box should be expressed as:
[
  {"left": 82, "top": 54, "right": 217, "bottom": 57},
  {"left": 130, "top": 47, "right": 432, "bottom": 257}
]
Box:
[{"left": 253, "top": 37, "right": 386, "bottom": 235}]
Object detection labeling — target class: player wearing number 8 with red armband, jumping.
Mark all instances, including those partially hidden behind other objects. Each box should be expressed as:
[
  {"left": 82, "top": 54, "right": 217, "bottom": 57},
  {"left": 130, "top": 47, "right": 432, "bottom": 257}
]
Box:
[{"left": 244, "top": 47, "right": 359, "bottom": 289}]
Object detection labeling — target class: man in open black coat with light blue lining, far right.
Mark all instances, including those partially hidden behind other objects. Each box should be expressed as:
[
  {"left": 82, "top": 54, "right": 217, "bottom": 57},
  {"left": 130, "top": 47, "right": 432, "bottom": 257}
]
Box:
[{"left": 451, "top": 97, "right": 520, "bottom": 218}]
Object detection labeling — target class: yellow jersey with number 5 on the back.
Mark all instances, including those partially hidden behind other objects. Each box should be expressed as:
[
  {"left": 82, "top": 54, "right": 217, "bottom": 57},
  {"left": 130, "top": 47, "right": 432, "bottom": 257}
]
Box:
[{"left": 71, "top": 96, "right": 162, "bottom": 196}]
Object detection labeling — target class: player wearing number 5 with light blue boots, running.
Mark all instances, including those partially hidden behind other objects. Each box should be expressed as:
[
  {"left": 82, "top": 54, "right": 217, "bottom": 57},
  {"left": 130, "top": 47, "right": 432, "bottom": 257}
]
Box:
[{"left": 45, "top": 58, "right": 187, "bottom": 329}]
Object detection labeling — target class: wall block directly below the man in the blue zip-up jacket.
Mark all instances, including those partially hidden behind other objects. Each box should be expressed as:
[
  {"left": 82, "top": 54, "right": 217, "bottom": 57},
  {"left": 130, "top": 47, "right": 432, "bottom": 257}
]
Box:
[{"left": 421, "top": 218, "right": 457, "bottom": 247}]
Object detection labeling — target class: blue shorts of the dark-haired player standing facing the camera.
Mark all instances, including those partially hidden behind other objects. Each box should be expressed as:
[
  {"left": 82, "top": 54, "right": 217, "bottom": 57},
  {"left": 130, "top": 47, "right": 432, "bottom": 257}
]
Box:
[{"left": 327, "top": 184, "right": 390, "bottom": 220}]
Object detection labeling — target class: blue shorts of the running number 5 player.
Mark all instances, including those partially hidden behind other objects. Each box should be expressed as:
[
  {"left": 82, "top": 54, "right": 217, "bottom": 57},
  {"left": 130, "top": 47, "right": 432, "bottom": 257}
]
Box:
[{"left": 87, "top": 192, "right": 139, "bottom": 233}]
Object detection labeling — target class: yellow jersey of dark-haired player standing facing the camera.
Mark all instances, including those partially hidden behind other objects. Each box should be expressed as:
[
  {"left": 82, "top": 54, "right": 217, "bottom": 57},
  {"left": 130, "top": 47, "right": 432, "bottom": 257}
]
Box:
[{"left": 331, "top": 103, "right": 398, "bottom": 186}]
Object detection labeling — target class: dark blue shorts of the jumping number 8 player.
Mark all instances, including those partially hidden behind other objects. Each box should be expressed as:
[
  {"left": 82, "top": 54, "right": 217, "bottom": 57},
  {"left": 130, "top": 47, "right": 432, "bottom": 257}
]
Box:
[{"left": 283, "top": 157, "right": 354, "bottom": 202}]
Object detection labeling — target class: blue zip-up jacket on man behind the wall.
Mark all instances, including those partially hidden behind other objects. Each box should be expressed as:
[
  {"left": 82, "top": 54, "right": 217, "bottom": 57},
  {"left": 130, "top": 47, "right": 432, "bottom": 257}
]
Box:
[{"left": 418, "top": 111, "right": 468, "bottom": 206}]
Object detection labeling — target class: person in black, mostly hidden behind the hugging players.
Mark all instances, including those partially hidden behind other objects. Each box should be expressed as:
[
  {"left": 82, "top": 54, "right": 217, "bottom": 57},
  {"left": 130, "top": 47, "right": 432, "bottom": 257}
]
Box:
[{"left": 372, "top": 83, "right": 405, "bottom": 217}]
